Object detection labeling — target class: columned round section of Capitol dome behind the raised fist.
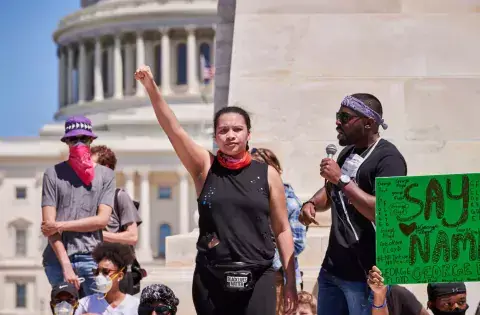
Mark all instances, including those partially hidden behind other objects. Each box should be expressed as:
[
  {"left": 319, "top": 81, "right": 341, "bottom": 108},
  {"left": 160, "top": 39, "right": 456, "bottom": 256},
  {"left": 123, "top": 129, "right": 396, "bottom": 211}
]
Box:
[{"left": 53, "top": 0, "right": 217, "bottom": 119}]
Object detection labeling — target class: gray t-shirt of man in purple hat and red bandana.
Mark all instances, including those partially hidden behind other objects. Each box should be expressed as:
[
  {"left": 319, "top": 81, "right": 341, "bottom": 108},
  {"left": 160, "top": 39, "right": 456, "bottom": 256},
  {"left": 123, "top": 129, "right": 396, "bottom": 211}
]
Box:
[{"left": 42, "top": 162, "right": 115, "bottom": 265}]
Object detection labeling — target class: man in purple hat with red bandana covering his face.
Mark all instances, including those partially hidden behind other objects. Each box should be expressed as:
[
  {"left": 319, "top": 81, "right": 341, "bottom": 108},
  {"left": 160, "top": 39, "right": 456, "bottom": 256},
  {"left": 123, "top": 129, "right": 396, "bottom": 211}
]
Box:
[{"left": 41, "top": 116, "right": 115, "bottom": 297}]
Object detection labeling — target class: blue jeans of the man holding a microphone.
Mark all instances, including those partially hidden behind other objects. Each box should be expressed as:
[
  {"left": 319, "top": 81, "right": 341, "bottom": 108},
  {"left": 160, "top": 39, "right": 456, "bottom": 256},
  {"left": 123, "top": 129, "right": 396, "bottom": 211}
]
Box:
[{"left": 317, "top": 268, "right": 372, "bottom": 315}]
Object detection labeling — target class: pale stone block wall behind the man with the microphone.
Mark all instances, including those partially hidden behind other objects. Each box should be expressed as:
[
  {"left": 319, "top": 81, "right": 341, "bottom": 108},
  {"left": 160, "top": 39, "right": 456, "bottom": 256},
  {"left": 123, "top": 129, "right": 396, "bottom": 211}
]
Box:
[{"left": 229, "top": 0, "right": 480, "bottom": 314}]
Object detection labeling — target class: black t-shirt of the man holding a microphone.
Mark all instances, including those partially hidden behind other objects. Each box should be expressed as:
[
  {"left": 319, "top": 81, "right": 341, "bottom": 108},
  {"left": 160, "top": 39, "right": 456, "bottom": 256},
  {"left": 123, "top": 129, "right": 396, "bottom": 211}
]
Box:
[{"left": 322, "top": 139, "right": 407, "bottom": 282}]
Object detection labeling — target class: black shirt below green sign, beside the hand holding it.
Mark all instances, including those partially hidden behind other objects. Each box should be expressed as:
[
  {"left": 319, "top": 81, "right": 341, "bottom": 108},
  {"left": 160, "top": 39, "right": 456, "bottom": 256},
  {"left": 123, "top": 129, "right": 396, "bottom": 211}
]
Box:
[{"left": 387, "top": 285, "right": 423, "bottom": 315}]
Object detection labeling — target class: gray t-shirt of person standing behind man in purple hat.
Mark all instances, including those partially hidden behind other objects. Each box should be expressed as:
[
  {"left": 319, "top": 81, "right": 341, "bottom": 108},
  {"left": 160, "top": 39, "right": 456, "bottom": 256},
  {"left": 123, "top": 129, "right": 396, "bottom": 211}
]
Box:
[{"left": 107, "top": 189, "right": 142, "bottom": 233}]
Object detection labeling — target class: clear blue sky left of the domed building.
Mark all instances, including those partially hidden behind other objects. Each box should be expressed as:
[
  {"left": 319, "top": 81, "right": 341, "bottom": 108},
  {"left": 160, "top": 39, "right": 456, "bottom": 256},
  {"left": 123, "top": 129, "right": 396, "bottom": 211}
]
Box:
[{"left": 0, "top": 0, "right": 80, "bottom": 137}]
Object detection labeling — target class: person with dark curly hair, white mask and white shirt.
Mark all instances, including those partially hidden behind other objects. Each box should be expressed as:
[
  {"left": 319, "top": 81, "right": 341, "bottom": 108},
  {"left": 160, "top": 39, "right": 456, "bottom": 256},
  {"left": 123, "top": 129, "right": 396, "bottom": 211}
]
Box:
[{"left": 75, "top": 243, "right": 140, "bottom": 315}]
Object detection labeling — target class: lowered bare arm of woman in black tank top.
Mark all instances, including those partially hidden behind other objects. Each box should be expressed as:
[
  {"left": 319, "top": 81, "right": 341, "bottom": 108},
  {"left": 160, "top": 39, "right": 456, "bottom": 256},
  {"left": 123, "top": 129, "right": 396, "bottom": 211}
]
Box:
[{"left": 268, "top": 166, "right": 297, "bottom": 314}]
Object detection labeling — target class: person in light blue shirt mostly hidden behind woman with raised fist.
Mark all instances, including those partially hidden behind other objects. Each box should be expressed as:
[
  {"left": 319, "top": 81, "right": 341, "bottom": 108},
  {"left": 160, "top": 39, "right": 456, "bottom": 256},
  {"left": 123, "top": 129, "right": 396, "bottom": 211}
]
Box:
[{"left": 250, "top": 148, "right": 307, "bottom": 315}]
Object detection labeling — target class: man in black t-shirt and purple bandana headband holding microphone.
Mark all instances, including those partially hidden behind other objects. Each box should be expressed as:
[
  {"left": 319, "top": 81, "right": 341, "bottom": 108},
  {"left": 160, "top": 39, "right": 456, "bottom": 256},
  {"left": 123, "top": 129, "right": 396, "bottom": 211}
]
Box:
[{"left": 300, "top": 93, "right": 407, "bottom": 315}]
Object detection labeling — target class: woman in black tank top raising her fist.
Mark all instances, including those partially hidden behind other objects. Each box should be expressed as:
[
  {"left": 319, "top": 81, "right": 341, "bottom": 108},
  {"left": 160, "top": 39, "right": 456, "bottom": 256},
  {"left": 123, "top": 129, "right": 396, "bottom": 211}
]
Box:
[{"left": 135, "top": 66, "right": 297, "bottom": 315}]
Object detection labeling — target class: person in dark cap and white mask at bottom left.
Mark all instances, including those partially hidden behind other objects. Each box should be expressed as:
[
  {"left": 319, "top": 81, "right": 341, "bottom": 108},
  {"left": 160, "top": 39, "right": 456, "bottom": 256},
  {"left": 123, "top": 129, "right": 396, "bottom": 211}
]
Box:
[{"left": 50, "top": 282, "right": 78, "bottom": 315}]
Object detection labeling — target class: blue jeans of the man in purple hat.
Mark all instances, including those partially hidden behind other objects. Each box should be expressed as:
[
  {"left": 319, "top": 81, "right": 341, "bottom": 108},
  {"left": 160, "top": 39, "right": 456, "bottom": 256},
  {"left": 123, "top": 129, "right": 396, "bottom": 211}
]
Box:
[{"left": 45, "top": 254, "right": 97, "bottom": 297}]
